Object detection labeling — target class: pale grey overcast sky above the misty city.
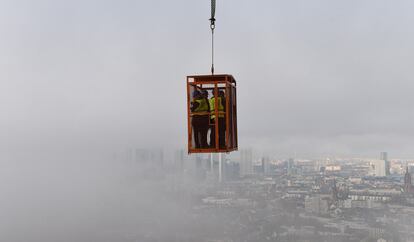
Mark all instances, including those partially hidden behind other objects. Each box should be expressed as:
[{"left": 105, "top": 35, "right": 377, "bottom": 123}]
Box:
[{"left": 0, "top": 0, "right": 414, "bottom": 157}]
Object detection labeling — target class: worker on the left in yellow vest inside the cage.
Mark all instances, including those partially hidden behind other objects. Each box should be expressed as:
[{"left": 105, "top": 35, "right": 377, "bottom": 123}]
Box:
[{"left": 191, "top": 90, "right": 209, "bottom": 149}]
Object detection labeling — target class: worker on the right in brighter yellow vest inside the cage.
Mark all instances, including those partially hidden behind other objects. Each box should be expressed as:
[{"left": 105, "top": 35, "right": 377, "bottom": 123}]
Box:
[{"left": 209, "top": 91, "right": 226, "bottom": 149}]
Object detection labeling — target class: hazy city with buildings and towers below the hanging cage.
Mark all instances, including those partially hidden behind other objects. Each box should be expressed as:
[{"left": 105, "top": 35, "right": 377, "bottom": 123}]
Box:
[{"left": 114, "top": 149, "right": 414, "bottom": 242}]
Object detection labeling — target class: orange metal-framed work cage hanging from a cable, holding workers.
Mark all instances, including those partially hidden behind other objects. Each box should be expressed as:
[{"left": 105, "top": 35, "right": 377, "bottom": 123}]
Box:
[{"left": 187, "top": 74, "right": 237, "bottom": 153}]
